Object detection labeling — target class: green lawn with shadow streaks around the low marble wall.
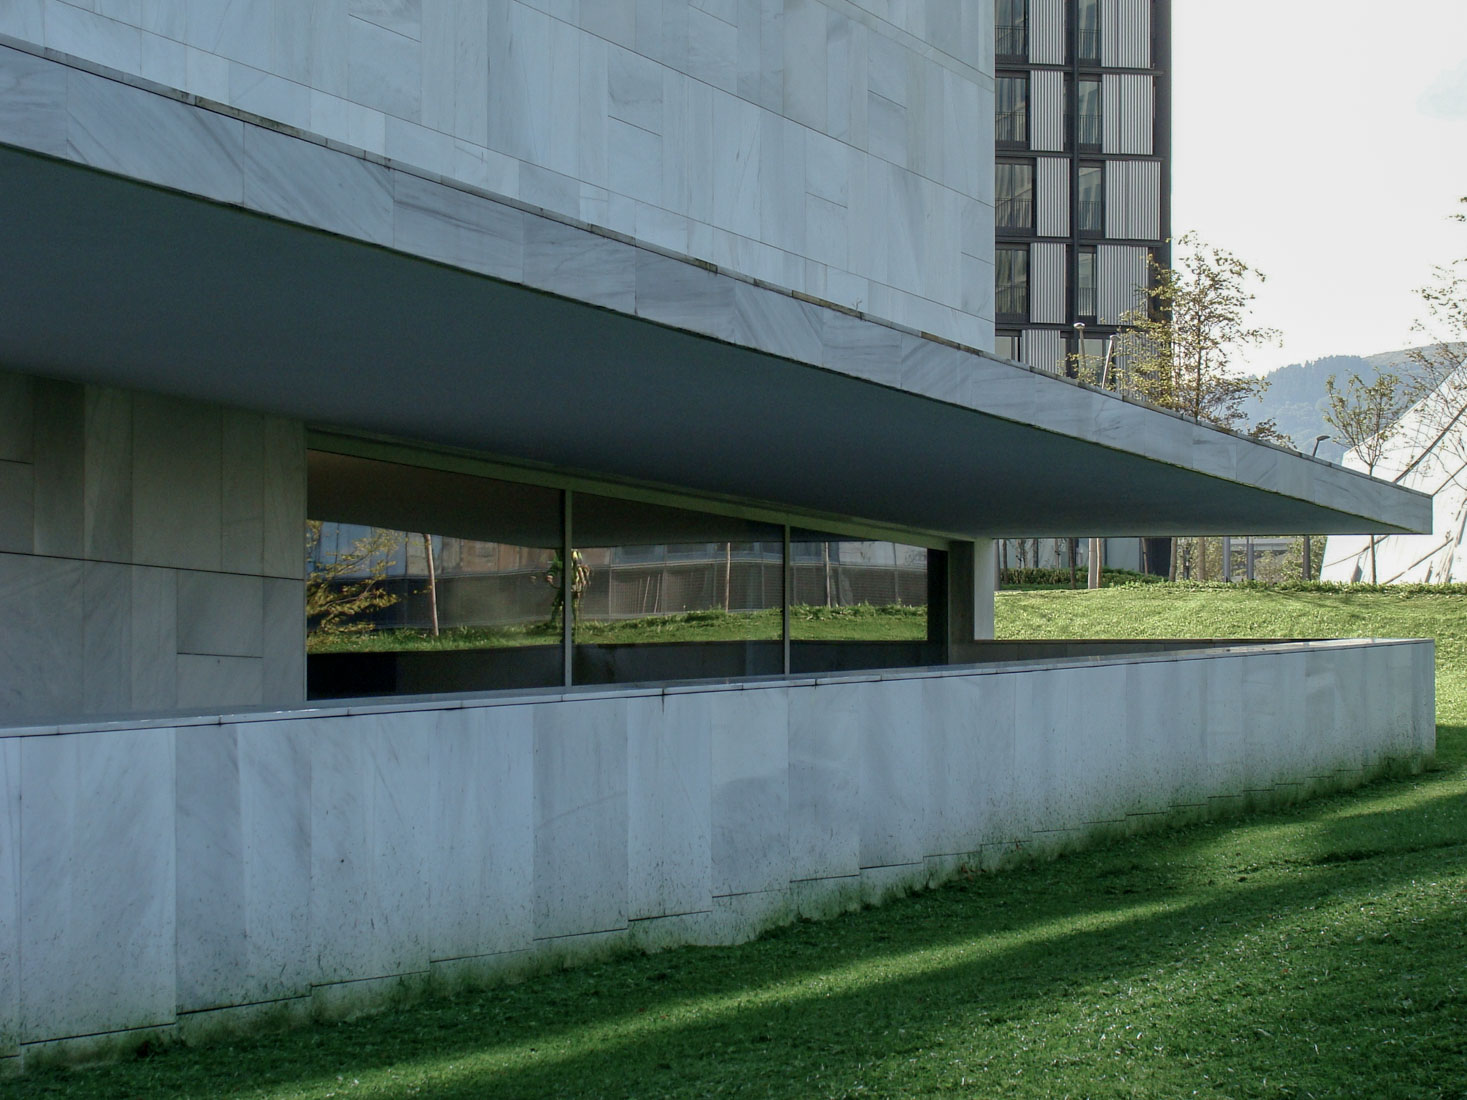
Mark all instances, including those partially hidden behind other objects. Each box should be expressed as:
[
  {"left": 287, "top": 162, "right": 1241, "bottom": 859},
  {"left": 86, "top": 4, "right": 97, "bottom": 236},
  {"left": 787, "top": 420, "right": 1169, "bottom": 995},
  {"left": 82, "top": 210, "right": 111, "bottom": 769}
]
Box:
[{"left": 14, "top": 588, "right": 1467, "bottom": 1100}]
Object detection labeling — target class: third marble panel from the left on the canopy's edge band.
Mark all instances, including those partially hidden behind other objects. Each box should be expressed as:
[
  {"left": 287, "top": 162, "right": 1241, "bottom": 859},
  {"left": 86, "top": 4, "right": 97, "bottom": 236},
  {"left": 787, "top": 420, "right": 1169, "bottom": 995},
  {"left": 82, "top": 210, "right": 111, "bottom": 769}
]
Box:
[{"left": 244, "top": 126, "right": 392, "bottom": 245}]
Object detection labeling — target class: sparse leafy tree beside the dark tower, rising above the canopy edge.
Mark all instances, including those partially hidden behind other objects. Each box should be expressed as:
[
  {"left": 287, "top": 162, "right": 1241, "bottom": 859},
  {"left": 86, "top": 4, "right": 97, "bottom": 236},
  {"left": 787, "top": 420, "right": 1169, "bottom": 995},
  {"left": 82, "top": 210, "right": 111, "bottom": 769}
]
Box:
[{"left": 1118, "top": 233, "right": 1282, "bottom": 581}]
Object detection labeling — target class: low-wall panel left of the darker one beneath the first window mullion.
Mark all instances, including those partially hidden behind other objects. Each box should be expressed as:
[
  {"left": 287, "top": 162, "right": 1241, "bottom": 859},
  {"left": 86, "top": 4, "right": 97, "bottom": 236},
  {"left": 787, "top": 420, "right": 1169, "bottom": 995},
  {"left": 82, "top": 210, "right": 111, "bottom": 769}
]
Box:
[{"left": 427, "top": 707, "right": 534, "bottom": 961}]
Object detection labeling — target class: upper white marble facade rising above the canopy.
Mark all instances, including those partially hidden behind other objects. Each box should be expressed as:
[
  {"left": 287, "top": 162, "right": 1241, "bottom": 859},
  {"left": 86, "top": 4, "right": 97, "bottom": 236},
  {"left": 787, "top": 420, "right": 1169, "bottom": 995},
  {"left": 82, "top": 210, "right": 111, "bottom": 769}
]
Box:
[{"left": 0, "top": 0, "right": 993, "bottom": 348}]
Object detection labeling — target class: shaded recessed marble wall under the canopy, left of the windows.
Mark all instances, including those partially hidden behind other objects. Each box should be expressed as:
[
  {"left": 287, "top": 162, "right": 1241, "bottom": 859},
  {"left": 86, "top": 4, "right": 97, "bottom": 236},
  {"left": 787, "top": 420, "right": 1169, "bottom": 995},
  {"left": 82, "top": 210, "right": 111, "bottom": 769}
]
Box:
[{"left": 0, "top": 373, "right": 305, "bottom": 725}]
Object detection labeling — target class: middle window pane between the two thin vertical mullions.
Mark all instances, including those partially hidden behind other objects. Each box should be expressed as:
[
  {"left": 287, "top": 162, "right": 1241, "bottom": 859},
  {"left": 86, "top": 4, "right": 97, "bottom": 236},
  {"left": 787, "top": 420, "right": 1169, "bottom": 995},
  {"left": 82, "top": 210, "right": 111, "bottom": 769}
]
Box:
[{"left": 571, "top": 493, "right": 783, "bottom": 683}]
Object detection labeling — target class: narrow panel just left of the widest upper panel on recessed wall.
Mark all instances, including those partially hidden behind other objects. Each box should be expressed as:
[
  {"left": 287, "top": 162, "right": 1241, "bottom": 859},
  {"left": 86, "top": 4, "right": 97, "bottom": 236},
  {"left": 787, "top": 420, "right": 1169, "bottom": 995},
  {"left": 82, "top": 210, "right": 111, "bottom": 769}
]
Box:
[{"left": 82, "top": 386, "right": 132, "bottom": 562}]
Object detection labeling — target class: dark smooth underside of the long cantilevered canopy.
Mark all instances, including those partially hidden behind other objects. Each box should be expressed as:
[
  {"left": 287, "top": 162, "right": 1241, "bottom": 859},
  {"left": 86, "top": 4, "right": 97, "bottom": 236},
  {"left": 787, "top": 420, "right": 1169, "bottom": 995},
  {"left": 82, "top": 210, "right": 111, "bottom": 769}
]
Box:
[{"left": 0, "top": 148, "right": 1430, "bottom": 535}]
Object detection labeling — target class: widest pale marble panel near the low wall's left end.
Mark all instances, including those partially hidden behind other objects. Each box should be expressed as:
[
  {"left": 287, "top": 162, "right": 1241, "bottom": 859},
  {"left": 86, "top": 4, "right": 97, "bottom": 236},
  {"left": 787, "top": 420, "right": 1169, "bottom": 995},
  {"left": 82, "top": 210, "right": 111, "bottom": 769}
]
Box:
[{"left": 21, "top": 729, "right": 176, "bottom": 1043}]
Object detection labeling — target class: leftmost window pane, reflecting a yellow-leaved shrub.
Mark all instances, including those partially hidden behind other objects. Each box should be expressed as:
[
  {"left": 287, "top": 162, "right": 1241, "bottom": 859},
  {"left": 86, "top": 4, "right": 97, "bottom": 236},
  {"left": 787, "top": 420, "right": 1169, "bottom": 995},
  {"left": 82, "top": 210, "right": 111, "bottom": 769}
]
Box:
[{"left": 307, "top": 452, "right": 562, "bottom": 698}]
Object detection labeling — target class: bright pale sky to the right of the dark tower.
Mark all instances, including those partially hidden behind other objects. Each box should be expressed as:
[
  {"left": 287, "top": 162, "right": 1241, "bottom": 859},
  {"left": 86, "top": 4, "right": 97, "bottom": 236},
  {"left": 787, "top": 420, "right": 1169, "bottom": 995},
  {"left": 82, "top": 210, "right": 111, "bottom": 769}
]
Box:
[{"left": 1172, "top": 0, "right": 1467, "bottom": 373}]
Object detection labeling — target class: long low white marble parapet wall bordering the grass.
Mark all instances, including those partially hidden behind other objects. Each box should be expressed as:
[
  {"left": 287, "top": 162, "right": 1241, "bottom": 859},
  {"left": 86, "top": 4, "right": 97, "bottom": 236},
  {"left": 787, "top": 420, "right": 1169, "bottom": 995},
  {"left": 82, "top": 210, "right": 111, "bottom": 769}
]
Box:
[{"left": 0, "top": 641, "right": 1435, "bottom": 1066}]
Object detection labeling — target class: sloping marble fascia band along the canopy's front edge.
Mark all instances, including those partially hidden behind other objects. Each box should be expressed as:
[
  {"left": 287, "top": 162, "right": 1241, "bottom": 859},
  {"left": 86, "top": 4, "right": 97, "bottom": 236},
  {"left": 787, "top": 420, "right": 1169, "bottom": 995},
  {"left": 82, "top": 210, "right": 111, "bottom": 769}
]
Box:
[{"left": 0, "top": 45, "right": 1429, "bottom": 529}]
